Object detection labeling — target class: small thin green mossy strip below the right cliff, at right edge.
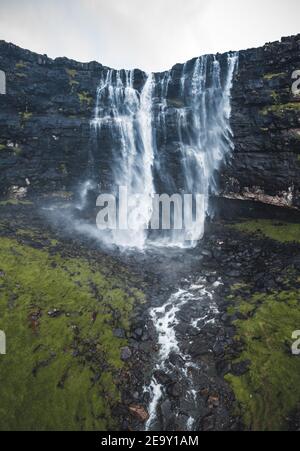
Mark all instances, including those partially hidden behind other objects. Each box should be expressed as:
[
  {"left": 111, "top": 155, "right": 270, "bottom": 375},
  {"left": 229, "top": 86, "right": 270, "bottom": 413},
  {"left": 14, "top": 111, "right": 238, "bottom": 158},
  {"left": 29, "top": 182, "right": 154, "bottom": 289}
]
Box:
[{"left": 232, "top": 219, "right": 300, "bottom": 243}]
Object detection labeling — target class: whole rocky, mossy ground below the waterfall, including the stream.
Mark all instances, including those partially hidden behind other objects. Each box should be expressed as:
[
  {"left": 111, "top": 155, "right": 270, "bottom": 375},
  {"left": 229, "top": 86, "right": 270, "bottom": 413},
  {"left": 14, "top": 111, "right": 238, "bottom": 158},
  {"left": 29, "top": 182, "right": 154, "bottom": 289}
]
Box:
[{"left": 0, "top": 202, "right": 300, "bottom": 431}]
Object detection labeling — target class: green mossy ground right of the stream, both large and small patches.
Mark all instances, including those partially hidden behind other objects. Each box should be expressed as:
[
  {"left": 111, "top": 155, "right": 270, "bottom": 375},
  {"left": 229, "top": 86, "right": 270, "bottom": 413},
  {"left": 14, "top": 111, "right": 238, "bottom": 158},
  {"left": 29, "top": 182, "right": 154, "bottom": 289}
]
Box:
[{"left": 226, "top": 220, "right": 300, "bottom": 431}]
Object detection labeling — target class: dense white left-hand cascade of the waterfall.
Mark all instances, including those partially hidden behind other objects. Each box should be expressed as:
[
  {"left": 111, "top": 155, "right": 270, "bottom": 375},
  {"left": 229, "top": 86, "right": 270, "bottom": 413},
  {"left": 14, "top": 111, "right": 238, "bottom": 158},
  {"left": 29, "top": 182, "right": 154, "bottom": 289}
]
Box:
[{"left": 92, "top": 70, "right": 154, "bottom": 248}]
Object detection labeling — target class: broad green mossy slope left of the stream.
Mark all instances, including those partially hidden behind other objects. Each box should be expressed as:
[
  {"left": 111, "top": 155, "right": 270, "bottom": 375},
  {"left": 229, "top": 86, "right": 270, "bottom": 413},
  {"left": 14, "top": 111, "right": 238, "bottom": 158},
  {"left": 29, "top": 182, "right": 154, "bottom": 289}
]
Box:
[{"left": 0, "top": 237, "right": 144, "bottom": 430}]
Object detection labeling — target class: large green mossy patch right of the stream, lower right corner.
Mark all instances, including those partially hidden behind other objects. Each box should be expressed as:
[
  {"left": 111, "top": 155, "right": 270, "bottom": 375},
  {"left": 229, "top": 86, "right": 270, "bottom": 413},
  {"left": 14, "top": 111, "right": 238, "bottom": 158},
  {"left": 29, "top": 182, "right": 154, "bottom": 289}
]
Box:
[{"left": 226, "top": 291, "right": 300, "bottom": 431}]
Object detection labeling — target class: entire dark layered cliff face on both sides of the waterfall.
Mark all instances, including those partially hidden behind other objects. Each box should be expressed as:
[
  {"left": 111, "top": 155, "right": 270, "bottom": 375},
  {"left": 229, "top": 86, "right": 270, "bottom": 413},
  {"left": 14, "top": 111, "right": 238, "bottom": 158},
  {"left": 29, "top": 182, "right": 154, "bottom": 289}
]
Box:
[{"left": 0, "top": 35, "right": 300, "bottom": 206}]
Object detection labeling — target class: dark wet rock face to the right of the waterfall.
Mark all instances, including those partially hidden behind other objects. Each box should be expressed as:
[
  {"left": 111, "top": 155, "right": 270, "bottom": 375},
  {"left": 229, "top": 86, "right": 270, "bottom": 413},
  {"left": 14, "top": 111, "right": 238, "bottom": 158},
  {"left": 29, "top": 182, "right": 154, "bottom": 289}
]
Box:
[{"left": 222, "top": 35, "right": 300, "bottom": 206}]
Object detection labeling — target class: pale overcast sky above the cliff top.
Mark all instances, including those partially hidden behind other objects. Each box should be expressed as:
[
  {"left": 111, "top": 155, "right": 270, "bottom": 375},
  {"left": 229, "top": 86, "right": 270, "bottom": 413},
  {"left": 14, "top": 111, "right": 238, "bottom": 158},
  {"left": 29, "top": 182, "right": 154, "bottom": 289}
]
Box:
[{"left": 0, "top": 0, "right": 300, "bottom": 71}]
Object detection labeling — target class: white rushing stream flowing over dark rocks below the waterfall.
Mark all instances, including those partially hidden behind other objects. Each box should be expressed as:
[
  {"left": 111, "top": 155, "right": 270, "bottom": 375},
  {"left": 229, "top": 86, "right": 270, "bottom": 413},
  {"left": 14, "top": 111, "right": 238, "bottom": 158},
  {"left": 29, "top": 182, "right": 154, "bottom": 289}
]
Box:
[{"left": 145, "top": 278, "right": 221, "bottom": 430}]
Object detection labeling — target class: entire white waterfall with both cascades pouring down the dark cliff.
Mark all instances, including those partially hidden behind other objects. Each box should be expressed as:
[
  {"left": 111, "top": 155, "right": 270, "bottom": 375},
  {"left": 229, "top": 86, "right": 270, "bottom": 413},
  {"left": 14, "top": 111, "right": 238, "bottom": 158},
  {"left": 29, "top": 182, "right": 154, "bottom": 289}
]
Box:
[{"left": 86, "top": 54, "right": 237, "bottom": 249}]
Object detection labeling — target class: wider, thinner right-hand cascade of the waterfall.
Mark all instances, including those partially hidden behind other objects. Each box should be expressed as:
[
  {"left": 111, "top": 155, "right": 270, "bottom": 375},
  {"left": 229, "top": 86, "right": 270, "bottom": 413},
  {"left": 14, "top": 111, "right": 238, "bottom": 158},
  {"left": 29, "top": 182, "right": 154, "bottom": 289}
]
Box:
[{"left": 152, "top": 54, "right": 237, "bottom": 247}]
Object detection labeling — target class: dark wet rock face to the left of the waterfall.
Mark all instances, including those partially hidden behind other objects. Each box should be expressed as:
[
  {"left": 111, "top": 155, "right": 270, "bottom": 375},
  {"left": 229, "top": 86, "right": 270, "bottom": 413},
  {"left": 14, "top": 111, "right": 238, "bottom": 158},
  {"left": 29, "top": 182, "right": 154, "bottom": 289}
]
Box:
[{"left": 0, "top": 41, "right": 145, "bottom": 195}]
